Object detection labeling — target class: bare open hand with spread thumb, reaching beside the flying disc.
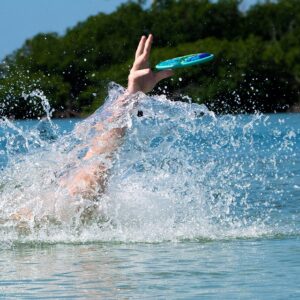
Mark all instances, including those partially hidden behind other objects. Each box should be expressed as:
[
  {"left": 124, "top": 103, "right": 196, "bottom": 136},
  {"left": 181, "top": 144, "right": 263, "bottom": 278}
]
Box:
[{"left": 128, "top": 34, "right": 174, "bottom": 94}]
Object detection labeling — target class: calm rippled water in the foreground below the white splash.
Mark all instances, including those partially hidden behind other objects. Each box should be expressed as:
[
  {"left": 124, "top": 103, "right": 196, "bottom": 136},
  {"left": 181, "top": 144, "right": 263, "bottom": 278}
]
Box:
[{"left": 0, "top": 237, "right": 300, "bottom": 299}]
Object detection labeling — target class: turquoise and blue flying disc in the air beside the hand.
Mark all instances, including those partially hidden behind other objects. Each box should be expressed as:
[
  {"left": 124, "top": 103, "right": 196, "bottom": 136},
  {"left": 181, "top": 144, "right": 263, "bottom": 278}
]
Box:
[{"left": 155, "top": 53, "right": 214, "bottom": 70}]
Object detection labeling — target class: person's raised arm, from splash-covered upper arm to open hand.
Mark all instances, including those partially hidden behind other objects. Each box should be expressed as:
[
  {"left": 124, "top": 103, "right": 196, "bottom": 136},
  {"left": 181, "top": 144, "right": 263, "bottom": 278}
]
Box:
[{"left": 61, "top": 34, "right": 173, "bottom": 198}]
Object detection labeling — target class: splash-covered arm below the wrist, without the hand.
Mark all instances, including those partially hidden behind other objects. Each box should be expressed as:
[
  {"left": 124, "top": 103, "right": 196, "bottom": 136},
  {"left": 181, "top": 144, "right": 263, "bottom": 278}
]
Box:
[{"left": 60, "top": 93, "right": 132, "bottom": 198}]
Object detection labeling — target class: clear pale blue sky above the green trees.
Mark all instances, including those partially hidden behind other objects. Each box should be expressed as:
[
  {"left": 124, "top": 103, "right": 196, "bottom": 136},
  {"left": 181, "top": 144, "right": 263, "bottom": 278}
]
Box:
[{"left": 0, "top": 0, "right": 257, "bottom": 60}]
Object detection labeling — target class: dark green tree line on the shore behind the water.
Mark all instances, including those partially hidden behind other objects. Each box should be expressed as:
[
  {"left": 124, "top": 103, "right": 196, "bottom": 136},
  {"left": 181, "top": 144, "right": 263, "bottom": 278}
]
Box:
[{"left": 0, "top": 0, "right": 300, "bottom": 118}]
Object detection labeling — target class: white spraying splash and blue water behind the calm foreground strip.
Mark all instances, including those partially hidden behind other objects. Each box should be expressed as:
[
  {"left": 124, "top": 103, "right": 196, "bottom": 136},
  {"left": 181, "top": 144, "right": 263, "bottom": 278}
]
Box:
[{"left": 0, "top": 85, "right": 299, "bottom": 245}]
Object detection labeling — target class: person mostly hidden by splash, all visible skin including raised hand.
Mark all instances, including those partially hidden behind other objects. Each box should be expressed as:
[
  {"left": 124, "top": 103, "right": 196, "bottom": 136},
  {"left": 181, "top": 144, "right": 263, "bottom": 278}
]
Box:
[{"left": 11, "top": 34, "right": 173, "bottom": 221}]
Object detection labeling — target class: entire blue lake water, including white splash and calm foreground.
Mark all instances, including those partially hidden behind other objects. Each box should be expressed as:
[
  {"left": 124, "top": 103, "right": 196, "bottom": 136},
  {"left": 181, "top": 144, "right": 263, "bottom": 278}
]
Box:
[{"left": 0, "top": 87, "right": 300, "bottom": 299}]
